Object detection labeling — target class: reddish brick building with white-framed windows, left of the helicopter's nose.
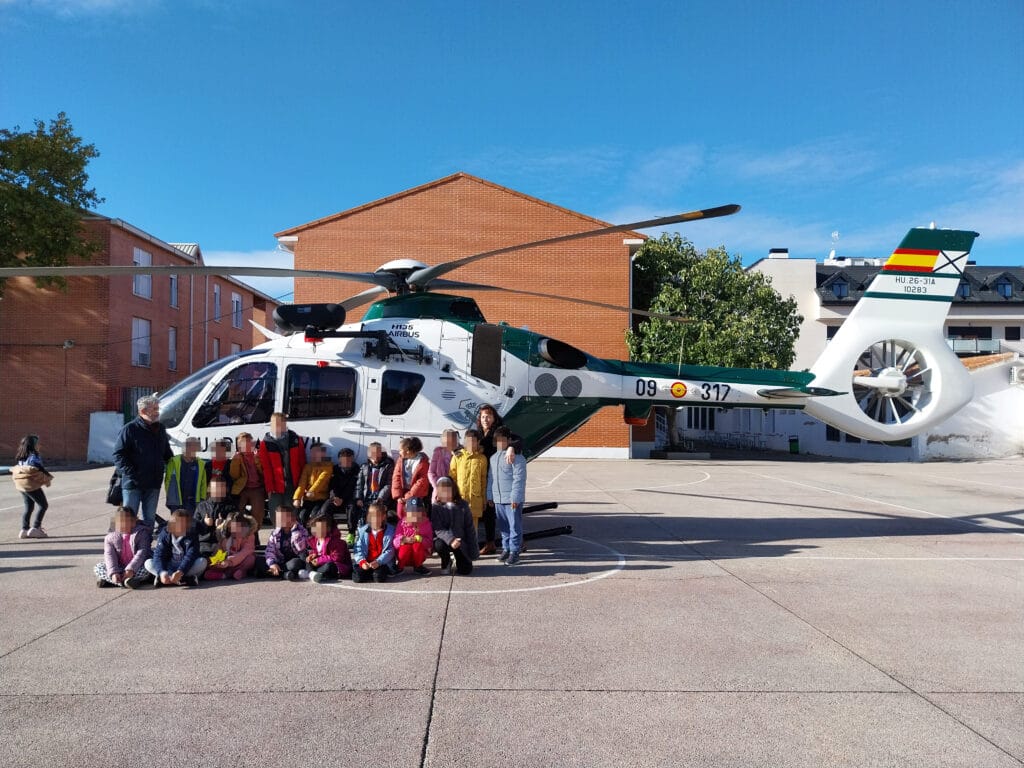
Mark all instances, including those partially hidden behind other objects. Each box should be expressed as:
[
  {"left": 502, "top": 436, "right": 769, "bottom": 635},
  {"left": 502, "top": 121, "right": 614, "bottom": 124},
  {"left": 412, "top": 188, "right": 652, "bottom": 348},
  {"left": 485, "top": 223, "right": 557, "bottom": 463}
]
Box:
[{"left": 0, "top": 215, "right": 274, "bottom": 461}]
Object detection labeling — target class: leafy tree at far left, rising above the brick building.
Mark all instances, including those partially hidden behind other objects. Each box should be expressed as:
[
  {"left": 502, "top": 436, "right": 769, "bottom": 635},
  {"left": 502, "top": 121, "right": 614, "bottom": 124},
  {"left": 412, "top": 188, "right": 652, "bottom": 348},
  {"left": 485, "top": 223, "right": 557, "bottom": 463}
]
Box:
[{"left": 0, "top": 112, "right": 103, "bottom": 289}]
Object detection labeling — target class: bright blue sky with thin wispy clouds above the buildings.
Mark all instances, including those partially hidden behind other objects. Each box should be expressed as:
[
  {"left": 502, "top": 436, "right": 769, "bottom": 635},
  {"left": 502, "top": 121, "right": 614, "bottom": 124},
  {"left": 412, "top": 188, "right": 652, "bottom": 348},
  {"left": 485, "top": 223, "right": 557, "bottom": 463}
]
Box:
[{"left": 0, "top": 0, "right": 1024, "bottom": 301}]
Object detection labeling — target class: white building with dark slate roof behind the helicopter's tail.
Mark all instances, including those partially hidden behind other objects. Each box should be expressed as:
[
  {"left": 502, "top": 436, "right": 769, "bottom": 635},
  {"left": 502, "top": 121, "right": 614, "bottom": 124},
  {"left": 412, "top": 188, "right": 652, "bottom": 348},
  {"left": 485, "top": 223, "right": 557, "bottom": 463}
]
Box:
[{"left": 678, "top": 250, "right": 1024, "bottom": 461}]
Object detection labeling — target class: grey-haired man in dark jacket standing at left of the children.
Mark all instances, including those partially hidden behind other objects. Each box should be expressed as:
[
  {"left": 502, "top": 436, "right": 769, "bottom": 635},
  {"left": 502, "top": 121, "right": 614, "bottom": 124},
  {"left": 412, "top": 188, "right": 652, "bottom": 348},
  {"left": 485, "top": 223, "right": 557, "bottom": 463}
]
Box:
[{"left": 114, "top": 394, "right": 174, "bottom": 525}]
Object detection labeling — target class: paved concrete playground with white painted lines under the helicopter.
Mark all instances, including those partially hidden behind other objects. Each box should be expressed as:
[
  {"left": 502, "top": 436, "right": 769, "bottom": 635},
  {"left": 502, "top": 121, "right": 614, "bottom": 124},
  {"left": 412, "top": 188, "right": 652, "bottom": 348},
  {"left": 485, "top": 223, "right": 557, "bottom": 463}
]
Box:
[{"left": 0, "top": 457, "right": 1024, "bottom": 768}]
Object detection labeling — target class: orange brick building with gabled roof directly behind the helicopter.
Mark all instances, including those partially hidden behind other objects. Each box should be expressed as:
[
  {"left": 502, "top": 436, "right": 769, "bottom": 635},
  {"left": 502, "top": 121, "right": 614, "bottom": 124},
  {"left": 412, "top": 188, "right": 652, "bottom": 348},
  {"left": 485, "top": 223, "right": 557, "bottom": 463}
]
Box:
[{"left": 276, "top": 173, "right": 640, "bottom": 457}]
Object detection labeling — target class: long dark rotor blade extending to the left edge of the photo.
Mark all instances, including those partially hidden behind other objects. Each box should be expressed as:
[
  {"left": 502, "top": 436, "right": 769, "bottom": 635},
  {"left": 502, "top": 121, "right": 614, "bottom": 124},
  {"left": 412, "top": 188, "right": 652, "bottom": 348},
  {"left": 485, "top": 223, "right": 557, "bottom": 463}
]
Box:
[{"left": 0, "top": 264, "right": 398, "bottom": 291}]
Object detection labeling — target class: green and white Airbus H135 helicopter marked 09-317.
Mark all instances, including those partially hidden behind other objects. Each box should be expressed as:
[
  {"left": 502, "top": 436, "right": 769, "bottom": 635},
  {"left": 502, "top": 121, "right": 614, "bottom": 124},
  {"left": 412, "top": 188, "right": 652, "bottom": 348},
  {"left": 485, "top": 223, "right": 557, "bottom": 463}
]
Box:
[{"left": 0, "top": 205, "right": 978, "bottom": 460}]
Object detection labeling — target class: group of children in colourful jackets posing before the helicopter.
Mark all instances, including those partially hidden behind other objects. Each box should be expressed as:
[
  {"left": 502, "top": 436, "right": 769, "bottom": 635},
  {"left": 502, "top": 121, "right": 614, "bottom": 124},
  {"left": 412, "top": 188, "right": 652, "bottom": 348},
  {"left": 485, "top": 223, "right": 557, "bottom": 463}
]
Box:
[{"left": 95, "top": 407, "right": 526, "bottom": 589}]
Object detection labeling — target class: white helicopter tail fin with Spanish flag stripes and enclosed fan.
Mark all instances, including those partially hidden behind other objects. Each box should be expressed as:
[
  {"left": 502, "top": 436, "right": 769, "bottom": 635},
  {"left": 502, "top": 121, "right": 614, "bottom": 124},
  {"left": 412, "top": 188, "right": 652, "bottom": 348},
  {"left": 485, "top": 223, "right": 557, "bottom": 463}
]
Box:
[{"left": 807, "top": 228, "right": 978, "bottom": 441}]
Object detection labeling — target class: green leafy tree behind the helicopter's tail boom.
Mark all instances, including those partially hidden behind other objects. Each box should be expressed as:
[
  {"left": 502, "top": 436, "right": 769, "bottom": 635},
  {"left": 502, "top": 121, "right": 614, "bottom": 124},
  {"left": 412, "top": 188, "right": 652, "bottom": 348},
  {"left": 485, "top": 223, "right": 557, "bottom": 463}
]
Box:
[{"left": 627, "top": 233, "right": 803, "bottom": 442}]
